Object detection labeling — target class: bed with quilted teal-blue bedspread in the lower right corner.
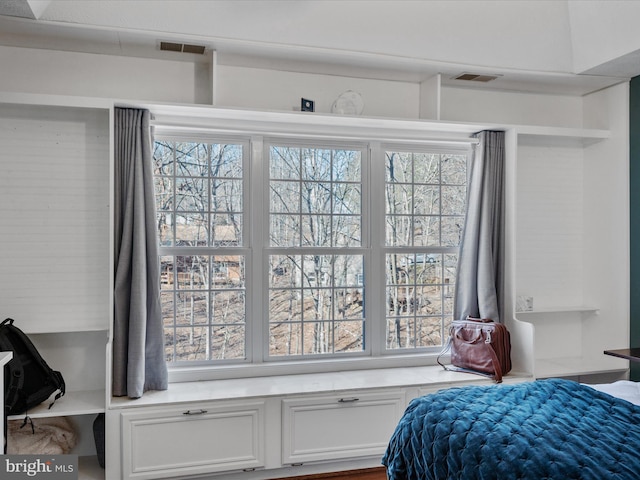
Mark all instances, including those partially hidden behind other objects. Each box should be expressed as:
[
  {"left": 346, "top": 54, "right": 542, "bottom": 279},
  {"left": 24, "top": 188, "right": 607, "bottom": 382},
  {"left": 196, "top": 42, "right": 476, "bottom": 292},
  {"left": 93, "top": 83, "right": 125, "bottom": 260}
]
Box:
[{"left": 382, "top": 379, "right": 640, "bottom": 480}]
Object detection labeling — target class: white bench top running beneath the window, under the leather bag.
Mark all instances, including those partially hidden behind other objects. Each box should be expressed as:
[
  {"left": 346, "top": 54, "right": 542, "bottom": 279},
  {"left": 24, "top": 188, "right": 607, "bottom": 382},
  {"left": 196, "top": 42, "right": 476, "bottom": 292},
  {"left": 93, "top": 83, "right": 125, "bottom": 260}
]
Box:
[{"left": 110, "top": 365, "right": 532, "bottom": 409}]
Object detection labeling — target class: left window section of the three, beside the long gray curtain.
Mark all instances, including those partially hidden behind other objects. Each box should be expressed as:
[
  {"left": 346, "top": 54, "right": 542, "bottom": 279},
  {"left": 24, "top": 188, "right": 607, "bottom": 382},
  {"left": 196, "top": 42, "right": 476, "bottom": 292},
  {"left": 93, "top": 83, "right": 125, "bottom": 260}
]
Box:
[{"left": 154, "top": 139, "right": 247, "bottom": 362}]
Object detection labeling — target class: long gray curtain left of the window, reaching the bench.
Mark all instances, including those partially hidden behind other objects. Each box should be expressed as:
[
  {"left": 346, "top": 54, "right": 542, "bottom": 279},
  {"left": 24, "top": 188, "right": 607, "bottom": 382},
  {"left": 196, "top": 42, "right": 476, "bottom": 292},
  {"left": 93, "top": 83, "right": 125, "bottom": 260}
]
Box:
[{"left": 112, "top": 108, "right": 168, "bottom": 398}]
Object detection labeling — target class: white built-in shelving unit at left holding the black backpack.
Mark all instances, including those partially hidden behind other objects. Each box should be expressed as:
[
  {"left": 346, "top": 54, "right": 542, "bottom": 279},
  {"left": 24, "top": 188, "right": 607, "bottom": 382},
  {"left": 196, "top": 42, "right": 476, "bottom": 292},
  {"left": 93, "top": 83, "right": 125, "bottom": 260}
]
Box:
[{"left": 0, "top": 95, "right": 111, "bottom": 479}]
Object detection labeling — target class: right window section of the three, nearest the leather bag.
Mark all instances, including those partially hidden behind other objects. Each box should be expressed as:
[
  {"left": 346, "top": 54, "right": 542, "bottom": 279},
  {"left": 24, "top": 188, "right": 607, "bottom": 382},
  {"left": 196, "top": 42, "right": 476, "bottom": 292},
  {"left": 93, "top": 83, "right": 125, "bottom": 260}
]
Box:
[{"left": 385, "top": 150, "right": 467, "bottom": 349}]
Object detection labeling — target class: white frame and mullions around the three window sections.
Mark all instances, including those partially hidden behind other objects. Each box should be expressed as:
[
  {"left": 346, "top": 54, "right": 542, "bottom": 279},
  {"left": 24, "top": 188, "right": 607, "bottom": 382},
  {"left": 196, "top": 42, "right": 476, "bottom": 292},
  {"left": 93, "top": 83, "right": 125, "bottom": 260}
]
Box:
[{"left": 156, "top": 112, "right": 477, "bottom": 382}]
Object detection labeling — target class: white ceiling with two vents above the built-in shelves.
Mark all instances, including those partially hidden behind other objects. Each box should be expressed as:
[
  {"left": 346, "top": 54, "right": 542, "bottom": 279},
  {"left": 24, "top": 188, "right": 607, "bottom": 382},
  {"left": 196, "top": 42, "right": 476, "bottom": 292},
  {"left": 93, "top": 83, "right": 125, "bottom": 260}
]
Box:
[{"left": 0, "top": 0, "right": 640, "bottom": 95}]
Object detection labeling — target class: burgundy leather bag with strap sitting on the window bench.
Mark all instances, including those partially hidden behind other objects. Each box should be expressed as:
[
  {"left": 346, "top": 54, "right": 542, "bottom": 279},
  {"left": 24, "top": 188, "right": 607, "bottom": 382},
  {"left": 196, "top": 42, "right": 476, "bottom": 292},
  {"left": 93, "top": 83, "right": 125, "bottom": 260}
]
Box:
[{"left": 438, "top": 317, "right": 511, "bottom": 383}]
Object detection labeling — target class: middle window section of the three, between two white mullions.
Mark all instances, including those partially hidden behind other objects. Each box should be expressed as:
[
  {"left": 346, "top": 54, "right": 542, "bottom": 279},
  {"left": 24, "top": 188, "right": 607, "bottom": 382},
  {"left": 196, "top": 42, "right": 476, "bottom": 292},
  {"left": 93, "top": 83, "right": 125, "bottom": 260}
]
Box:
[{"left": 268, "top": 144, "right": 365, "bottom": 357}]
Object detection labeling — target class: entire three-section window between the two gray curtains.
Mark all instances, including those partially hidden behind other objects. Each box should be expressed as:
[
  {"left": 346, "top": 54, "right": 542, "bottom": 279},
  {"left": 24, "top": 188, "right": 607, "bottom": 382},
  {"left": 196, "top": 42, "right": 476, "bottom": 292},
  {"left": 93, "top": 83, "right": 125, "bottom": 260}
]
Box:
[{"left": 154, "top": 136, "right": 468, "bottom": 372}]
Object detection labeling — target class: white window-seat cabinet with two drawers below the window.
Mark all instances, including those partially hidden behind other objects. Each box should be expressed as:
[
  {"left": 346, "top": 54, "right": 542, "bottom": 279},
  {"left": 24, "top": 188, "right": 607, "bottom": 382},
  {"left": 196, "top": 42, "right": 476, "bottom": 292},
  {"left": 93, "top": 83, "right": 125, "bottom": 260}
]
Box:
[{"left": 108, "top": 366, "right": 531, "bottom": 480}]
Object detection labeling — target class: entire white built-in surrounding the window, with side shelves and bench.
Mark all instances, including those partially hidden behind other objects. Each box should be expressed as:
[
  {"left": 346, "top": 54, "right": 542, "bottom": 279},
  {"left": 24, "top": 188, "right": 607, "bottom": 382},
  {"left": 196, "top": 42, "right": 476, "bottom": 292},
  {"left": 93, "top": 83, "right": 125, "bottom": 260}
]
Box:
[{"left": 0, "top": 69, "right": 629, "bottom": 480}]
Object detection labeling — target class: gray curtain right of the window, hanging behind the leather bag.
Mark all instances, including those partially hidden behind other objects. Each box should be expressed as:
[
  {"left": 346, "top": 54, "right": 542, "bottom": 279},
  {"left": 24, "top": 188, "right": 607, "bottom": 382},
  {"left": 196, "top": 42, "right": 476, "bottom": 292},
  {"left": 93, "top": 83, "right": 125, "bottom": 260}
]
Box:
[{"left": 453, "top": 131, "right": 504, "bottom": 322}]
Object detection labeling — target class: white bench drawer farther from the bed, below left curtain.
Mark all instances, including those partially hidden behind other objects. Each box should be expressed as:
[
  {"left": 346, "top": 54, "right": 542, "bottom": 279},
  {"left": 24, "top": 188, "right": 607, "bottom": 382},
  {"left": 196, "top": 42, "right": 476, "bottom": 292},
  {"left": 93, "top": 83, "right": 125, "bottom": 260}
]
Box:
[{"left": 121, "top": 402, "right": 264, "bottom": 479}]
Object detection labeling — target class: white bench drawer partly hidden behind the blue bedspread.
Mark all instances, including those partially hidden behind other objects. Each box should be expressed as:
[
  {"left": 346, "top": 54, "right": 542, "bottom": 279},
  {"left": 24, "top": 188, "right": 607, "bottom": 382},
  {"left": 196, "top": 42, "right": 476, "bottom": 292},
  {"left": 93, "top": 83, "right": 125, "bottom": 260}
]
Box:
[{"left": 282, "top": 390, "right": 405, "bottom": 464}]
